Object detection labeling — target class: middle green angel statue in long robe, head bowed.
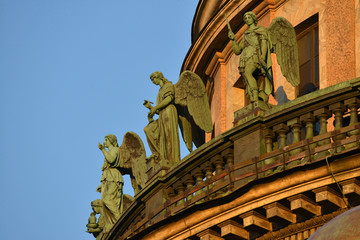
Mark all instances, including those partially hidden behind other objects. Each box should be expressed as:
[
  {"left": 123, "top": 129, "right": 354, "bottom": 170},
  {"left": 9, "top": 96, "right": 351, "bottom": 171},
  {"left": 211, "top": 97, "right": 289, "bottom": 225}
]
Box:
[{"left": 144, "top": 71, "right": 213, "bottom": 167}]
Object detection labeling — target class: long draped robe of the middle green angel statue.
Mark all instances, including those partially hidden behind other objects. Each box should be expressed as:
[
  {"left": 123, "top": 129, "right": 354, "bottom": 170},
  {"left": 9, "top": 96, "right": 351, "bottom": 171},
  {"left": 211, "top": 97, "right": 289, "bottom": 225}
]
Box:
[{"left": 144, "top": 81, "right": 180, "bottom": 166}]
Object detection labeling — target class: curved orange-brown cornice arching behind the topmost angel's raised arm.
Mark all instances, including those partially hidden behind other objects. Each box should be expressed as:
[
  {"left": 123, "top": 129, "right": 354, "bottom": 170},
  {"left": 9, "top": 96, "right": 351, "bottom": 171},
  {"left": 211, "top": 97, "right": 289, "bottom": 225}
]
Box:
[{"left": 181, "top": 0, "right": 286, "bottom": 81}]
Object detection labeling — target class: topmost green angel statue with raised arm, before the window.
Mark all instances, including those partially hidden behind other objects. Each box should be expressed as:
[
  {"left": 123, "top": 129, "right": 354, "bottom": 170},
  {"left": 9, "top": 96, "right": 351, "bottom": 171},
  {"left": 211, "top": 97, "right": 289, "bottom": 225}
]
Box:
[{"left": 225, "top": 12, "right": 300, "bottom": 103}]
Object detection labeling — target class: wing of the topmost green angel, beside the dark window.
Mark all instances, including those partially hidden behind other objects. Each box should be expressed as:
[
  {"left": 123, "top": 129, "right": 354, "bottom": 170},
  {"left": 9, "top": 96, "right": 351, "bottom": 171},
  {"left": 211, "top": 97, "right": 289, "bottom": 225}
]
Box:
[{"left": 268, "top": 17, "right": 300, "bottom": 87}]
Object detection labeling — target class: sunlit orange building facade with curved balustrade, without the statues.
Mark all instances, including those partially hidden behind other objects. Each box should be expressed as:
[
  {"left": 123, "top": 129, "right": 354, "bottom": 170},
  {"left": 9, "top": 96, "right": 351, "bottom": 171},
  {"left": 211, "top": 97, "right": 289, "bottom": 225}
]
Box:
[{"left": 107, "top": 0, "right": 360, "bottom": 240}]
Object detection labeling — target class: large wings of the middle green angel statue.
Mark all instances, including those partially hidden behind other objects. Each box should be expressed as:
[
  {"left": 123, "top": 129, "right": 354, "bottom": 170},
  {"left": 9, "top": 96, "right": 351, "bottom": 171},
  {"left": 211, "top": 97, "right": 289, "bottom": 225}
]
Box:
[{"left": 175, "top": 71, "right": 213, "bottom": 152}]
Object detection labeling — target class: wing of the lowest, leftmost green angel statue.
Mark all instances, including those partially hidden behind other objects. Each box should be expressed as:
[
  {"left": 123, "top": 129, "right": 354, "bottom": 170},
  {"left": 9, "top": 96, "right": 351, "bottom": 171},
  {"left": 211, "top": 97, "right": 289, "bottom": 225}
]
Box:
[{"left": 120, "top": 132, "right": 147, "bottom": 194}]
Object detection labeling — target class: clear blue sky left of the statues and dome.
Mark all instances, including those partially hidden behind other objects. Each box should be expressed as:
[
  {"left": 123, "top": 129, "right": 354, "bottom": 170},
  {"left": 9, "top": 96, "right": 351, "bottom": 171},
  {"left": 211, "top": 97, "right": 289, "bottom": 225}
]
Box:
[{"left": 0, "top": 0, "right": 198, "bottom": 240}]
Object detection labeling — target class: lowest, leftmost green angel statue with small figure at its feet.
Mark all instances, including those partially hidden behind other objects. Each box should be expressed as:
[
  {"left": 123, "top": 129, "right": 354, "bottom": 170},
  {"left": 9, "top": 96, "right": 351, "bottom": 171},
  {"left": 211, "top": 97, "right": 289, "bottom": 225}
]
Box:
[{"left": 87, "top": 132, "right": 147, "bottom": 239}]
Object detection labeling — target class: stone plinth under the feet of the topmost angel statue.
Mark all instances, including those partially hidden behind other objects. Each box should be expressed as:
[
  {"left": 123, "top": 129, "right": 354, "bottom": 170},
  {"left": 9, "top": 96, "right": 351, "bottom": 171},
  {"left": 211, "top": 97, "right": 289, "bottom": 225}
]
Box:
[{"left": 233, "top": 101, "right": 272, "bottom": 127}]
